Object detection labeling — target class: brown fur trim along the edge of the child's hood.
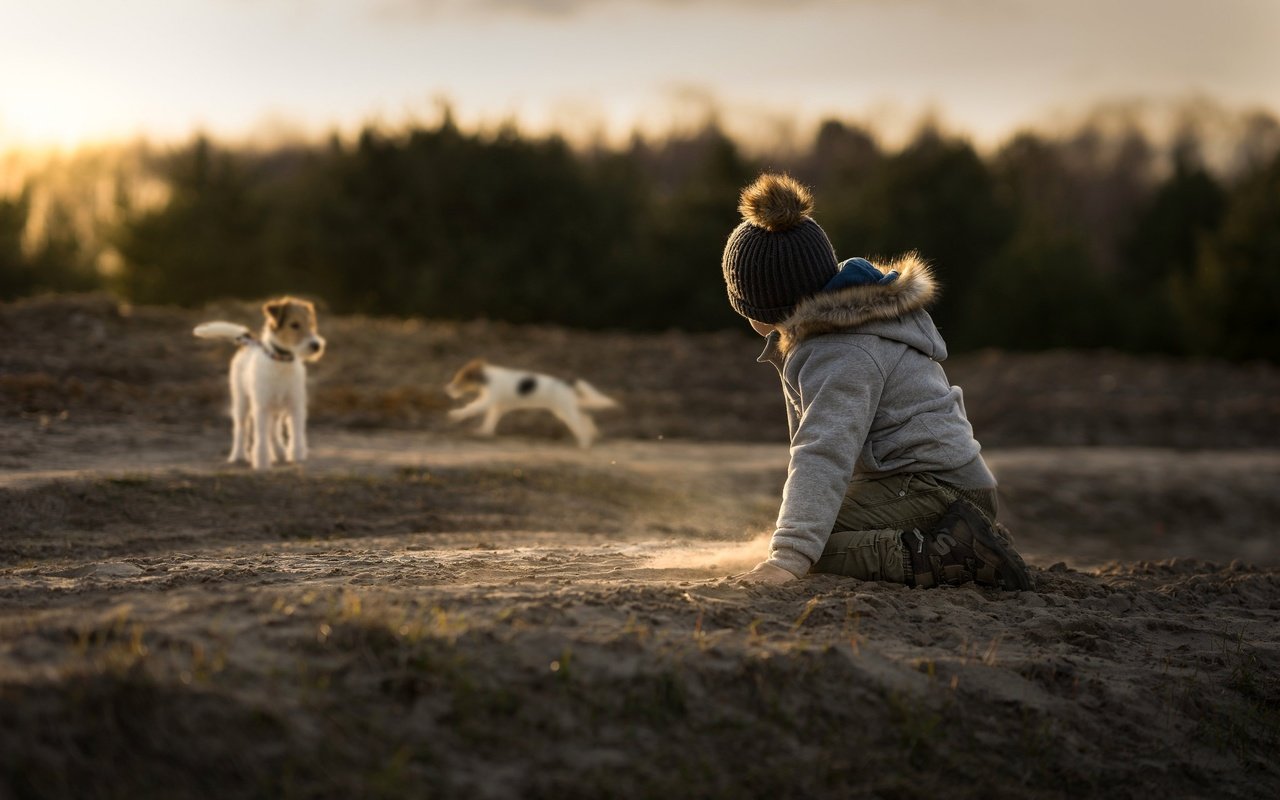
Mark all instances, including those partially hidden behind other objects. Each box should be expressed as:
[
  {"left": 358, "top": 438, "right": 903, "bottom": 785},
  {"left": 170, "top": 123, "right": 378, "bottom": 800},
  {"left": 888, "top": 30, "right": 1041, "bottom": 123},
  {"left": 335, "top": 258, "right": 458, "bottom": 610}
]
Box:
[{"left": 778, "top": 252, "right": 938, "bottom": 353}]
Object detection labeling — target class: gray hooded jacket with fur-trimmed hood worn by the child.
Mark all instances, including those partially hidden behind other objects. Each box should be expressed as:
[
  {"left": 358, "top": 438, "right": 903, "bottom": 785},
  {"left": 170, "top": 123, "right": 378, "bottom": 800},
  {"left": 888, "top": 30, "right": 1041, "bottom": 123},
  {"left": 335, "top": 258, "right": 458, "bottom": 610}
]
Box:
[{"left": 759, "top": 253, "right": 996, "bottom": 576}]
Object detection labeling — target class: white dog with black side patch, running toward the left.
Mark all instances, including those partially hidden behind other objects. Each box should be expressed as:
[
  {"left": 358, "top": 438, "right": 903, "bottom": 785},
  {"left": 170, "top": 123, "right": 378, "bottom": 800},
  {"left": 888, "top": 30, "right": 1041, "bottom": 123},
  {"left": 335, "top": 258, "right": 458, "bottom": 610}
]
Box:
[{"left": 444, "top": 358, "right": 617, "bottom": 447}]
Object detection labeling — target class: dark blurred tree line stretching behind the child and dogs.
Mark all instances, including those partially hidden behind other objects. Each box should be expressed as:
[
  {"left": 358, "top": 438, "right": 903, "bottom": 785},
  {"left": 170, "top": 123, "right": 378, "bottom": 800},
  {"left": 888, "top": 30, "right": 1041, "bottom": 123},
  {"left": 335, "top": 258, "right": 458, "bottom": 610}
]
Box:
[{"left": 0, "top": 115, "right": 1280, "bottom": 360}]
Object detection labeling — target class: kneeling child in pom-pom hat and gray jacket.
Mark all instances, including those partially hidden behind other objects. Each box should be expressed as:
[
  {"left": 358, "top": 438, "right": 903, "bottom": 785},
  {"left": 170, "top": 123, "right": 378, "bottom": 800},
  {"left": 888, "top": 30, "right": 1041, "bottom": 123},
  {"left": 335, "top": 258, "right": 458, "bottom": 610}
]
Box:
[{"left": 722, "top": 174, "right": 1032, "bottom": 589}]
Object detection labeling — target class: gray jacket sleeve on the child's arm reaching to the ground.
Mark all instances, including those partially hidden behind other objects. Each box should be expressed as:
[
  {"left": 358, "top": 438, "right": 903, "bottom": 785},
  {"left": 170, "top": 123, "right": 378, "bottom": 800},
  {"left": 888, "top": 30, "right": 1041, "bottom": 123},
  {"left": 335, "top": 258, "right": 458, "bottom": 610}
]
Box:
[{"left": 769, "top": 342, "right": 884, "bottom": 576}]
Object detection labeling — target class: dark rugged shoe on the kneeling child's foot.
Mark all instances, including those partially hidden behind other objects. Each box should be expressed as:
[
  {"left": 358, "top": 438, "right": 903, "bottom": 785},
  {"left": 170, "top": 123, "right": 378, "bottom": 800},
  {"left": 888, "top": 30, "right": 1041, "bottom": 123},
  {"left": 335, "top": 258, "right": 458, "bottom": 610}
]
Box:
[{"left": 902, "top": 500, "right": 1033, "bottom": 590}]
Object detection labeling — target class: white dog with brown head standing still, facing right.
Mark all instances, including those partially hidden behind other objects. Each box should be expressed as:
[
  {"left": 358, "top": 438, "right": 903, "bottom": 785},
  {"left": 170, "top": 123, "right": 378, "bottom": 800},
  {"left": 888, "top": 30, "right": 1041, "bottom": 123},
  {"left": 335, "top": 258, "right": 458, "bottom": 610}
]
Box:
[{"left": 193, "top": 297, "right": 324, "bottom": 470}]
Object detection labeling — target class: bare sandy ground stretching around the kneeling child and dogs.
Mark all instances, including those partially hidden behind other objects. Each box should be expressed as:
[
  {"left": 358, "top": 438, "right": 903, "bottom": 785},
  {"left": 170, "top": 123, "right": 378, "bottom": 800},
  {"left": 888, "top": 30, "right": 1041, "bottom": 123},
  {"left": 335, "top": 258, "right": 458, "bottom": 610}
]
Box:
[{"left": 0, "top": 294, "right": 1280, "bottom": 799}]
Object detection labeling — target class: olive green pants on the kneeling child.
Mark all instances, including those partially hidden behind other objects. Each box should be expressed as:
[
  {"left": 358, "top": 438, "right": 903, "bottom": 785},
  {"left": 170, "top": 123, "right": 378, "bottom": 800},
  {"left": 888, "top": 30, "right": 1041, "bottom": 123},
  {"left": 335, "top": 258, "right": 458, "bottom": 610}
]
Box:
[{"left": 810, "top": 474, "right": 997, "bottom": 584}]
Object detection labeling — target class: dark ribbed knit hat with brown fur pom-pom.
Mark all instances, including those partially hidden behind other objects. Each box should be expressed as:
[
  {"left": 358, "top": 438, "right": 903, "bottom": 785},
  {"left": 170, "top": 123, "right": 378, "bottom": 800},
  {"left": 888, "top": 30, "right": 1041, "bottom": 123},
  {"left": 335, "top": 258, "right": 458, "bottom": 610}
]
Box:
[{"left": 721, "top": 173, "right": 840, "bottom": 325}]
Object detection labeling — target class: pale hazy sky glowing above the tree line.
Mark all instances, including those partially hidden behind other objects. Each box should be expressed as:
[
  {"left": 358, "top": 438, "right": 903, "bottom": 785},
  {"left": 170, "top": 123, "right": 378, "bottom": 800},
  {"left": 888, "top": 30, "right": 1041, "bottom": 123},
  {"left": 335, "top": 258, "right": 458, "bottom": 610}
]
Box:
[{"left": 0, "top": 0, "right": 1280, "bottom": 148}]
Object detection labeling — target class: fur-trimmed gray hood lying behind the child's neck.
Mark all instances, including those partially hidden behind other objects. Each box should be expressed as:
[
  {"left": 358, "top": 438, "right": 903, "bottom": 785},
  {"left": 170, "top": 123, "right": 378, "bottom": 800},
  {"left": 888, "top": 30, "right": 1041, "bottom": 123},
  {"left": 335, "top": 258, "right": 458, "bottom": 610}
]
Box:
[{"left": 778, "top": 252, "right": 946, "bottom": 361}]
